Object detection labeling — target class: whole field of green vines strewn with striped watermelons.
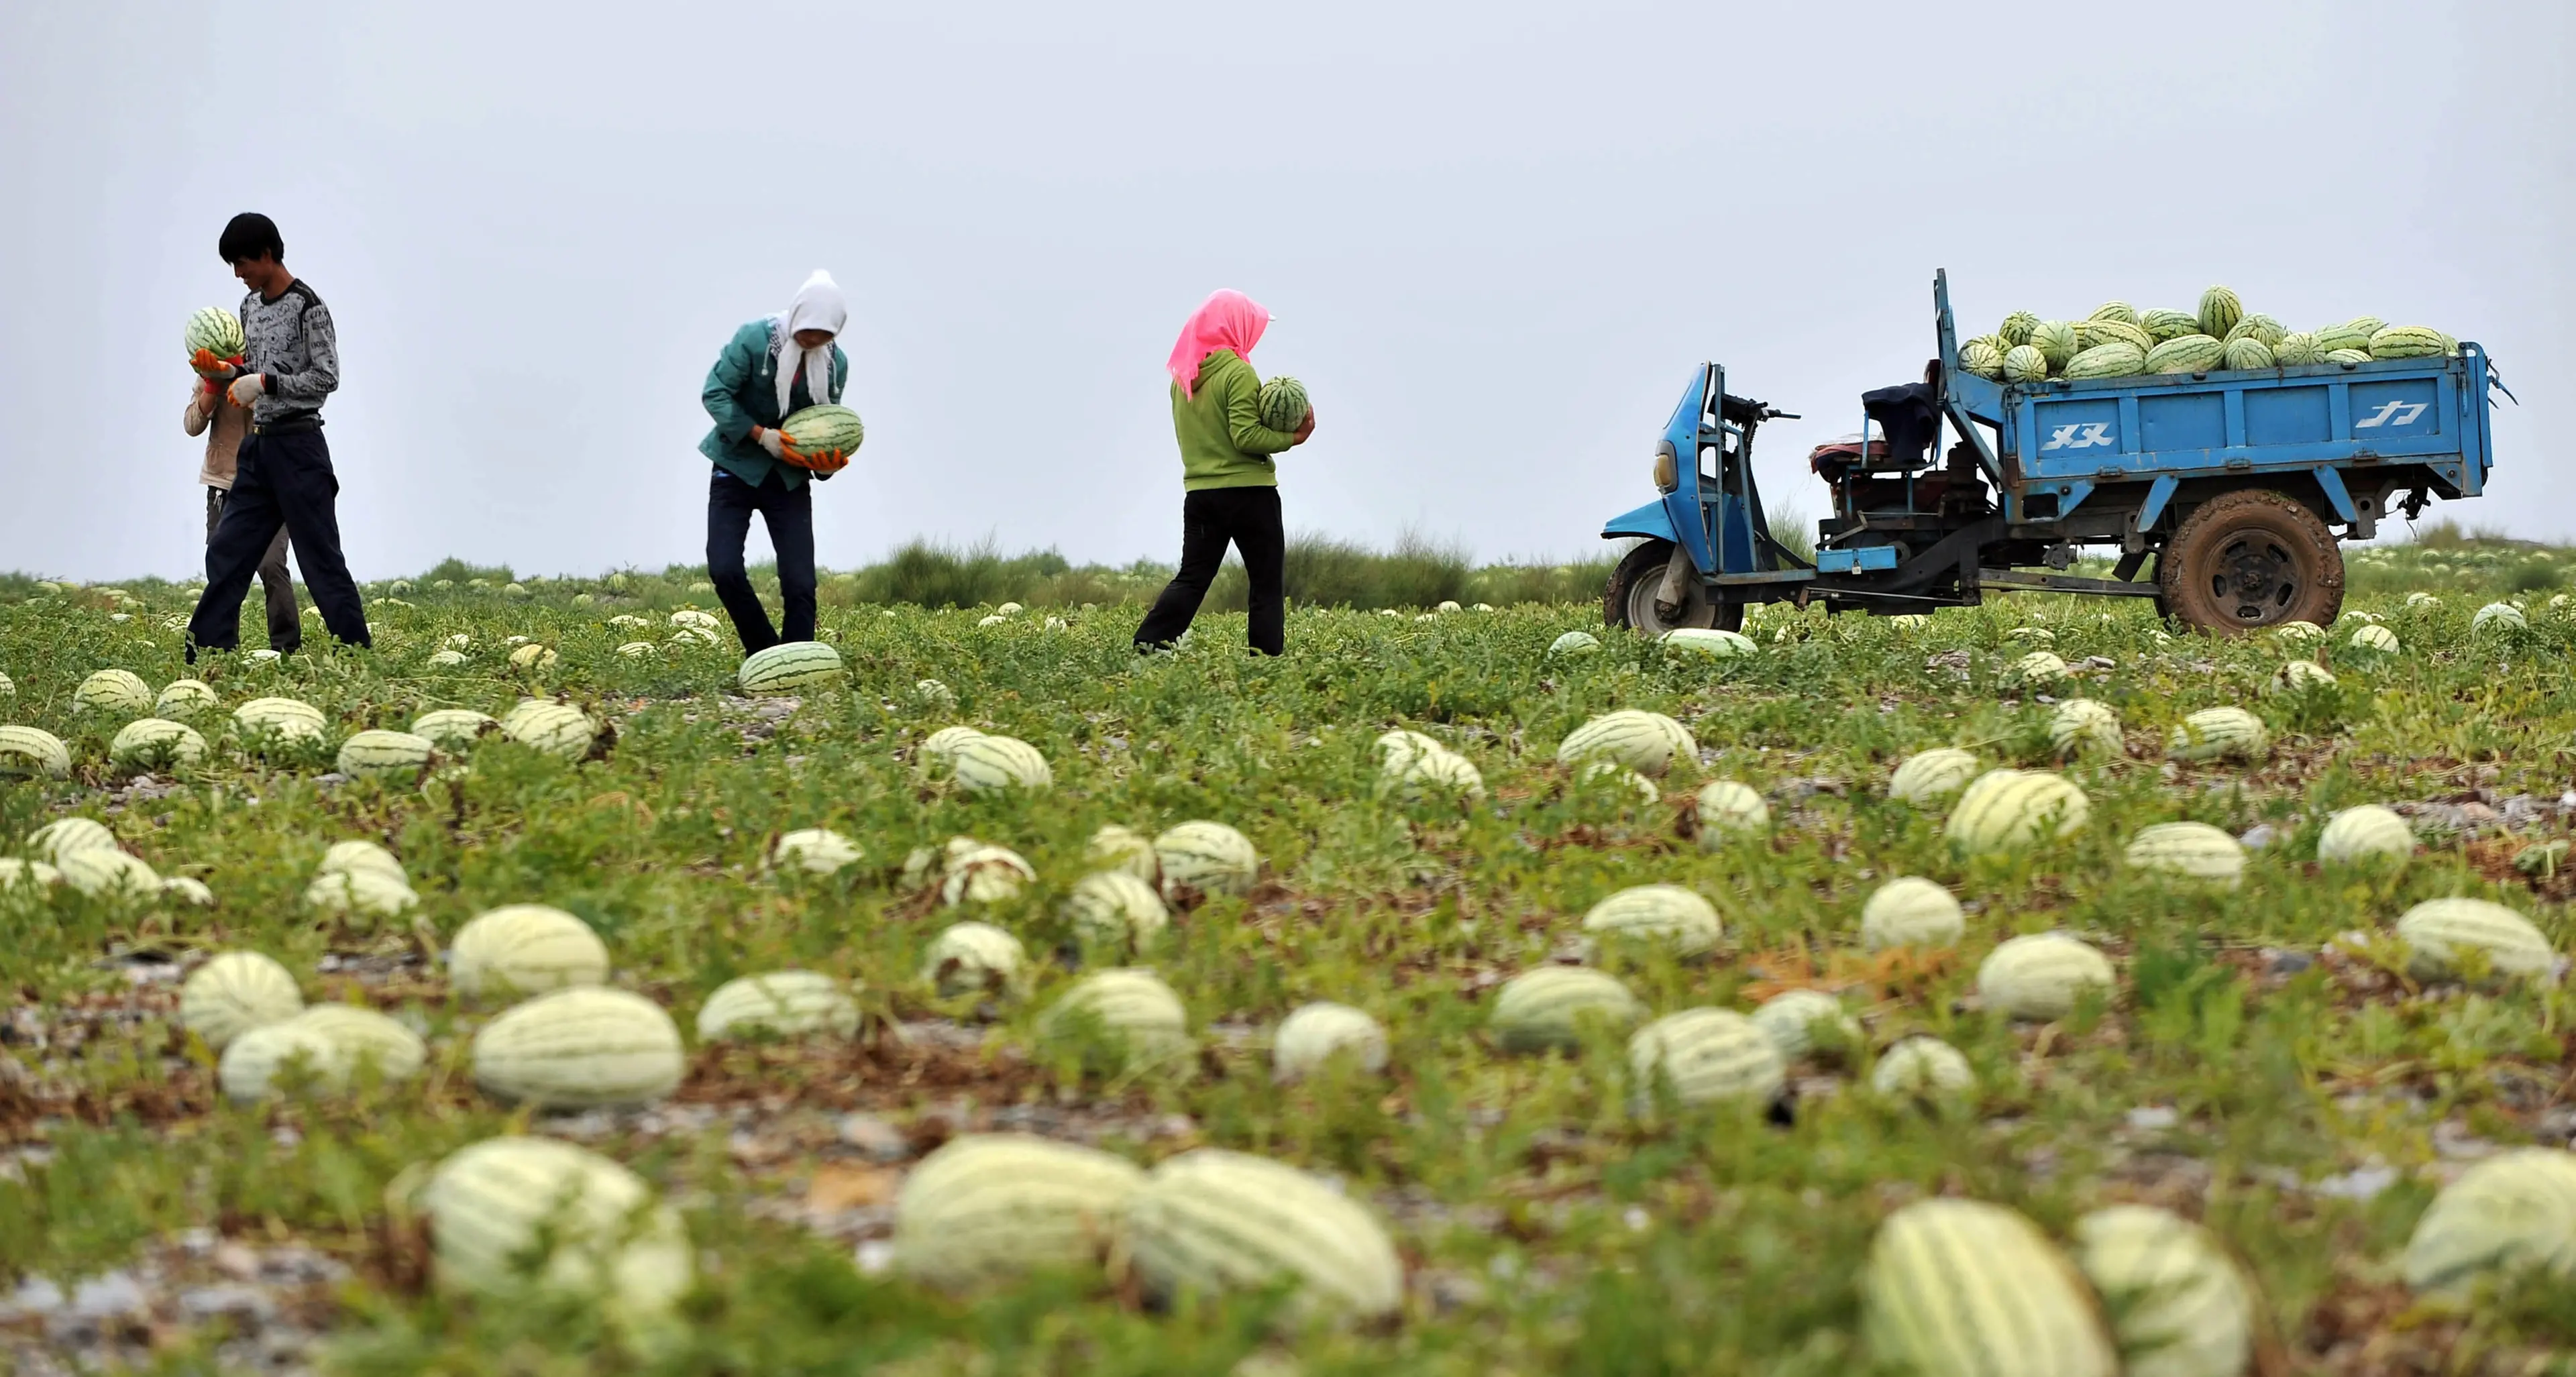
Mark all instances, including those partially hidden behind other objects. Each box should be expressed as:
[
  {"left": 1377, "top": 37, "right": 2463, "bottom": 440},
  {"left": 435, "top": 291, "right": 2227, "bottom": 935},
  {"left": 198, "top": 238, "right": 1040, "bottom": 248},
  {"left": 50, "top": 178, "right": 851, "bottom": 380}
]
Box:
[{"left": 0, "top": 541, "right": 2576, "bottom": 1377}]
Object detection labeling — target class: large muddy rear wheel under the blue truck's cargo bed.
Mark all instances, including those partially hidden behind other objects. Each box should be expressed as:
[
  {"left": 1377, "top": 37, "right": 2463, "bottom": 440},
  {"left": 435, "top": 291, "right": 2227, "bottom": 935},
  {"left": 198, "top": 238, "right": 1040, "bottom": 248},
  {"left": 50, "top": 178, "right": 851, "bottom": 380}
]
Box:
[{"left": 2156, "top": 489, "right": 2344, "bottom": 630}]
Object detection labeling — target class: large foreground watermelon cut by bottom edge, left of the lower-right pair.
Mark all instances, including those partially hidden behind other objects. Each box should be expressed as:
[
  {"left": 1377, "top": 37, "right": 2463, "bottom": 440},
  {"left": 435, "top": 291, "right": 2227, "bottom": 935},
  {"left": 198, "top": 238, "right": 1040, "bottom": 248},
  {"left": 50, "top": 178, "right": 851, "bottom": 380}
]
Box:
[{"left": 1860, "top": 1199, "right": 2120, "bottom": 1377}]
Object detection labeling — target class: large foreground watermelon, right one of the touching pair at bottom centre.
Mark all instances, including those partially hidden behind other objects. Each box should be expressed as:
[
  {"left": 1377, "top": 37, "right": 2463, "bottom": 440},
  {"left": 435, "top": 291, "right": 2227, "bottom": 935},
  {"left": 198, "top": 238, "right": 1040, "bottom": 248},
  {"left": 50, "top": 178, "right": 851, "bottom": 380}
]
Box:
[{"left": 1123, "top": 1148, "right": 1404, "bottom": 1321}]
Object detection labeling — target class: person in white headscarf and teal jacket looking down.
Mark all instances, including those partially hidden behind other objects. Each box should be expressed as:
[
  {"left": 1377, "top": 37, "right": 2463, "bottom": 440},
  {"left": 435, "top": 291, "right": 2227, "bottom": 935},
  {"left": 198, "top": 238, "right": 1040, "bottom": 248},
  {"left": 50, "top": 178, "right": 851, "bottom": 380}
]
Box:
[{"left": 698, "top": 268, "right": 850, "bottom": 654}]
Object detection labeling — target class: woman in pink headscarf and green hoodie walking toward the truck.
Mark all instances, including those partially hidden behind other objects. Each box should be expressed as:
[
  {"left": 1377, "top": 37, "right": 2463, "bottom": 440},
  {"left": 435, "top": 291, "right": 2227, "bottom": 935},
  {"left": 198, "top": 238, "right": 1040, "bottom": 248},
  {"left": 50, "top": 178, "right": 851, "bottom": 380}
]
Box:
[{"left": 1136, "top": 288, "right": 1313, "bottom": 654}]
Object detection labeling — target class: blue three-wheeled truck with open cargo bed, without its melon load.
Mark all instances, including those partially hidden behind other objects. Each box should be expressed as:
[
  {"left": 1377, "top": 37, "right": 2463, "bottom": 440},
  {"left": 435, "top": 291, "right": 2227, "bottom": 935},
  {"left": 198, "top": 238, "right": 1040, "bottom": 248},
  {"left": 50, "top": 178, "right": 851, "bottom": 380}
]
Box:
[{"left": 1602, "top": 273, "right": 2502, "bottom": 636}]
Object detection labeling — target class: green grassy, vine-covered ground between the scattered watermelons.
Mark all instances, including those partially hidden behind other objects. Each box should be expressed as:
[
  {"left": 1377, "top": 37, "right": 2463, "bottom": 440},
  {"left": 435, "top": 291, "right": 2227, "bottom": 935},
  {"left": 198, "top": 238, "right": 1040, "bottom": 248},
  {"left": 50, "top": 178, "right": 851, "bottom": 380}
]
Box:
[{"left": 0, "top": 533, "right": 2576, "bottom": 1374}]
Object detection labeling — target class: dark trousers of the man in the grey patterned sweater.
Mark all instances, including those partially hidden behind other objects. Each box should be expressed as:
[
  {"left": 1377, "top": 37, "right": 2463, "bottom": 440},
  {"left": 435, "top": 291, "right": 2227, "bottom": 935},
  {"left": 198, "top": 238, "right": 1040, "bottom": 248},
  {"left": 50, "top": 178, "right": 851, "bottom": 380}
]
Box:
[{"left": 188, "top": 430, "right": 374, "bottom": 664}]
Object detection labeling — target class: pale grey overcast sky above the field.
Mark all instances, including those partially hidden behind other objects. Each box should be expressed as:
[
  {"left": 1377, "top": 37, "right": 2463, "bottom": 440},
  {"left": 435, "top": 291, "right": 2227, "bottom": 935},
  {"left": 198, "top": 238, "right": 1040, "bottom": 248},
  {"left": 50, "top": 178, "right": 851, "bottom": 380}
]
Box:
[{"left": 0, "top": 0, "right": 2576, "bottom": 579}]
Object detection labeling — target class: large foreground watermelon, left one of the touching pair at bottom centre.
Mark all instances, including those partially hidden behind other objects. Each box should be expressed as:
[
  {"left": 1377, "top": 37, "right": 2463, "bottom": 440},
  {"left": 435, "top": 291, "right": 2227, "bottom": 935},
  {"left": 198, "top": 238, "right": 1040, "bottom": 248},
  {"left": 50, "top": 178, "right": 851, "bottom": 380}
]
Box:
[{"left": 894, "top": 1132, "right": 1144, "bottom": 1290}]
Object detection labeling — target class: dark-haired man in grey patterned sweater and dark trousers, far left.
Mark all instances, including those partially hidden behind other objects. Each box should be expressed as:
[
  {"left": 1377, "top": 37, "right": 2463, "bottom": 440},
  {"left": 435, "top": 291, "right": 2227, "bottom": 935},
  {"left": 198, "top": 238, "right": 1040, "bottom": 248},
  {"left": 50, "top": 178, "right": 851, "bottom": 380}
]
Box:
[{"left": 188, "top": 214, "right": 374, "bottom": 664}]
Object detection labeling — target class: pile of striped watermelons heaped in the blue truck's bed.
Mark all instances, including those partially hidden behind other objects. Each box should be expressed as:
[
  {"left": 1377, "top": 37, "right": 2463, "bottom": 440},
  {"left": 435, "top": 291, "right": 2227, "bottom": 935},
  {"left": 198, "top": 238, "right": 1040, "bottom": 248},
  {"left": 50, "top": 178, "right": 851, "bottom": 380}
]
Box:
[{"left": 1957, "top": 286, "right": 2460, "bottom": 384}]
